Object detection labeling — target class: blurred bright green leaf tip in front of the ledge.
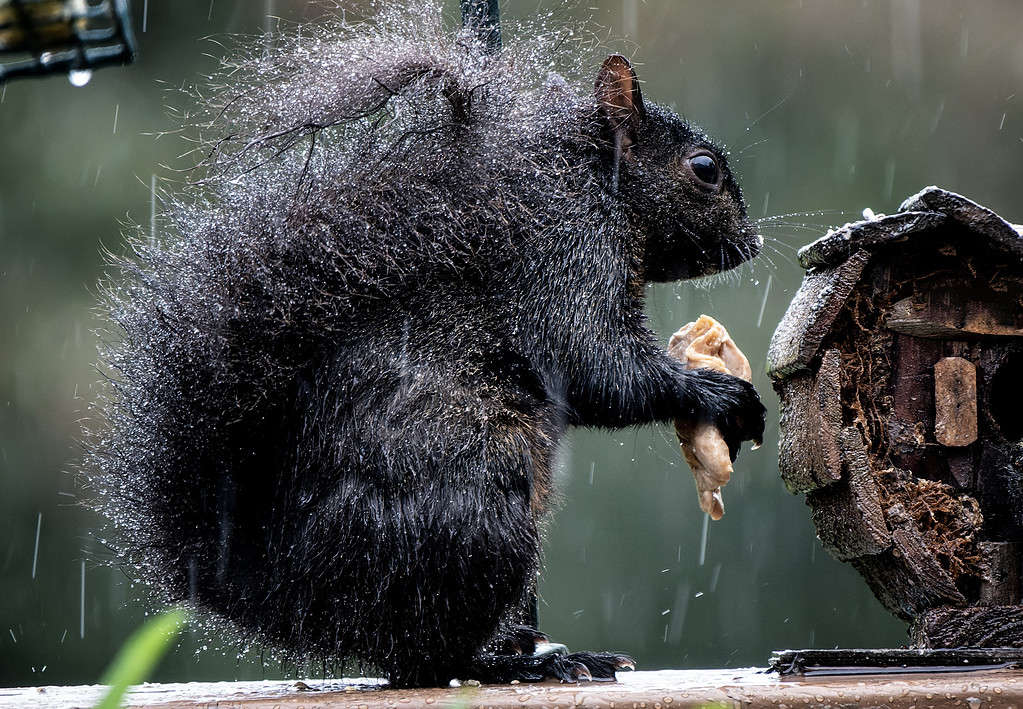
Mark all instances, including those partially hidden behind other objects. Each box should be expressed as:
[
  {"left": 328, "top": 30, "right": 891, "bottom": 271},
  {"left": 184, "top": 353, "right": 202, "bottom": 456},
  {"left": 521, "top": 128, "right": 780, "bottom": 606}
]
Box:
[{"left": 96, "top": 608, "right": 188, "bottom": 709}]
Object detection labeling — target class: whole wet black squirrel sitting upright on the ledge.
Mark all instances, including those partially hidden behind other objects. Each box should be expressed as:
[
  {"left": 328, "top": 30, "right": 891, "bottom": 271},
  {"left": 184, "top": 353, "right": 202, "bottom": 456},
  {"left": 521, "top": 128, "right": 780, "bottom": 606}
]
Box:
[{"left": 85, "top": 7, "right": 764, "bottom": 686}]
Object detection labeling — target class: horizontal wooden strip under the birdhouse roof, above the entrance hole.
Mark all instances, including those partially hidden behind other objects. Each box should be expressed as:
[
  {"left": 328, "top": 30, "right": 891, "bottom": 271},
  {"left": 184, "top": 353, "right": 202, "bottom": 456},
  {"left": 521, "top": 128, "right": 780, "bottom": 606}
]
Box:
[{"left": 885, "top": 289, "right": 1023, "bottom": 340}]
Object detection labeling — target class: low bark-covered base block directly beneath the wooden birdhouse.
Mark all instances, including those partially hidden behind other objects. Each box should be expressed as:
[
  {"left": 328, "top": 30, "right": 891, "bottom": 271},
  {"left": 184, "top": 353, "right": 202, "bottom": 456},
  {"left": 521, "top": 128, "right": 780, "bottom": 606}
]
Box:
[{"left": 909, "top": 606, "right": 1023, "bottom": 648}]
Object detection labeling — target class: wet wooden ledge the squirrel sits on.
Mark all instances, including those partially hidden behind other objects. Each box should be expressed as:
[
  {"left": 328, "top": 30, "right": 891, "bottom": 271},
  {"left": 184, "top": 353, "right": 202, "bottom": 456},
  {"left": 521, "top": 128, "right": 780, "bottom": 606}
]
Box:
[{"left": 7, "top": 669, "right": 1023, "bottom": 709}]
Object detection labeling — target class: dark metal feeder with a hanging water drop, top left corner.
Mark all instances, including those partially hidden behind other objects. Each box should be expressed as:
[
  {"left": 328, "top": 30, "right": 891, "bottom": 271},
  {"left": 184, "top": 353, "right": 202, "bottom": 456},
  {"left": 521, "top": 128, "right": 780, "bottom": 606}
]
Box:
[{"left": 0, "top": 0, "right": 135, "bottom": 85}]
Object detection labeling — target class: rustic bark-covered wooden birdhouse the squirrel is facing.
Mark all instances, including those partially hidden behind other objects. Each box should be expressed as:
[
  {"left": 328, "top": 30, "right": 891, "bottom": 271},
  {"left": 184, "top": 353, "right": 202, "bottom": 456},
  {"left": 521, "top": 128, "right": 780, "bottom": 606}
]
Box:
[{"left": 767, "top": 187, "right": 1023, "bottom": 648}]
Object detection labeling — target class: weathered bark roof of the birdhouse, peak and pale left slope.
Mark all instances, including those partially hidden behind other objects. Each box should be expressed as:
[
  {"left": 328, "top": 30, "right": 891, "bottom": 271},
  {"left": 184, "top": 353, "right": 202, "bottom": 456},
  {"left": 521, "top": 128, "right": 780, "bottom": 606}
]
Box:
[{"left": 767, "top": 186, "right": 1023, "bottom": 381}]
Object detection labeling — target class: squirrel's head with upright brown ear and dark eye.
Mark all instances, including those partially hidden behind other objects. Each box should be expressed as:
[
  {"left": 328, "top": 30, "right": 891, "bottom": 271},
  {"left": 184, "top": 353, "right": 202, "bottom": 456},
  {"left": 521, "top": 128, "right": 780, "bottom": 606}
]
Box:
[{"left": 594, "top": 54, "right": 763, "bottom": 281}]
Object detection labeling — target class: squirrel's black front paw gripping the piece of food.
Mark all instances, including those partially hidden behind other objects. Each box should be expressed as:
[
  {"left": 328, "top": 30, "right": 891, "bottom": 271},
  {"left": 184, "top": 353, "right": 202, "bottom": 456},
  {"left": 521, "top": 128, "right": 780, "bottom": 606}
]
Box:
[{"left": 690, "top": 369, "right": 767, "bottom": 460}]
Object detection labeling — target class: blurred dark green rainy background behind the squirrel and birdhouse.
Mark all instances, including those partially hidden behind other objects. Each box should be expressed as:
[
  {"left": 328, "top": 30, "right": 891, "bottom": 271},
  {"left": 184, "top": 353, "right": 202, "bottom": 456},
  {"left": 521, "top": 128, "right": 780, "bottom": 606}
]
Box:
[{"left": 0, "top": 0, "right": 1023, "bottom": 685}]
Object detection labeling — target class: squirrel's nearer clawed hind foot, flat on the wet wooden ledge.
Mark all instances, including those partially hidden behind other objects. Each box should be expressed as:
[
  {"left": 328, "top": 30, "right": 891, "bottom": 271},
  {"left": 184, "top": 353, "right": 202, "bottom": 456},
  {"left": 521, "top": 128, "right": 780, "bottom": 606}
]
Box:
[{"left": 472, "top": 653, "right": 635, "bottom": 684}]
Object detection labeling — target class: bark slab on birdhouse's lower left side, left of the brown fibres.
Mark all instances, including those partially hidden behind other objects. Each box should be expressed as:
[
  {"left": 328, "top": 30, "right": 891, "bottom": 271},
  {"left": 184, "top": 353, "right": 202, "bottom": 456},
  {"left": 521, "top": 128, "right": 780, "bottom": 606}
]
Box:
[{"left": 806, "top": 427, "right": 892, "bottom": 561}]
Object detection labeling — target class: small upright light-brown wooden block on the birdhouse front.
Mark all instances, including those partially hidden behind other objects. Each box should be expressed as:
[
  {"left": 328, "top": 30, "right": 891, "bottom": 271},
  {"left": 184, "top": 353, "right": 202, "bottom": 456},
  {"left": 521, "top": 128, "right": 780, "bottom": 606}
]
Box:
[{"left": 934, "top": 357, "right": 977, "bottom": 447}]
